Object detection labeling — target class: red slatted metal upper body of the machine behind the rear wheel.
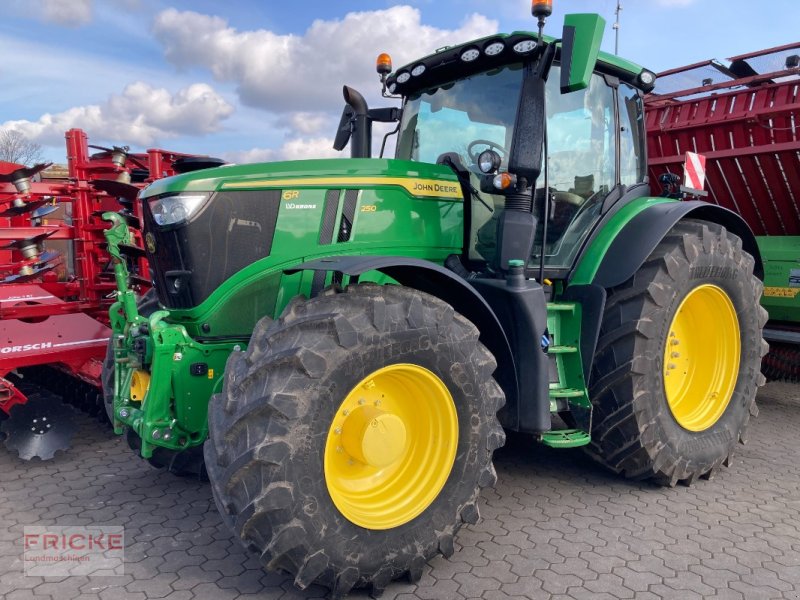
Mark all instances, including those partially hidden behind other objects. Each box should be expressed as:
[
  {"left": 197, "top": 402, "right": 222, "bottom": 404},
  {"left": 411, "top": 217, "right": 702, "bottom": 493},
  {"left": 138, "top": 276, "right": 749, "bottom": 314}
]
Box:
[{"left": 645, "top": 42, "right": 800, "bottom": 235}]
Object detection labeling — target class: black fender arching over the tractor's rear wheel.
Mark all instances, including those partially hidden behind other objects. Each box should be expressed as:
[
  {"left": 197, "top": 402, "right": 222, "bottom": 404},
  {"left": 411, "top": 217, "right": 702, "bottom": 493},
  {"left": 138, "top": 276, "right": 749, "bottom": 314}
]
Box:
[{"left": 592, "top": 200, "right": 764, "bottom": 289}]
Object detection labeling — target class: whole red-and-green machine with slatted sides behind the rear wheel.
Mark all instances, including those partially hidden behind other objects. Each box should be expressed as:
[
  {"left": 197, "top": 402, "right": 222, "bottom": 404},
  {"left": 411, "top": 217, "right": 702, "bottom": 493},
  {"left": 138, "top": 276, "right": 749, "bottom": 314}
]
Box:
[{"left": 645, "top": 42, "right": 800, "bottom": 381}]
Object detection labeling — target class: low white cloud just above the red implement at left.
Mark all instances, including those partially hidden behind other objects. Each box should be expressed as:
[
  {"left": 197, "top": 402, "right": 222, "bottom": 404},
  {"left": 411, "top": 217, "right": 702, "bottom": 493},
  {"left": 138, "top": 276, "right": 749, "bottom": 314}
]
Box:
[{"left": 0, "top": 82, "right": 234, "bottom": 146}]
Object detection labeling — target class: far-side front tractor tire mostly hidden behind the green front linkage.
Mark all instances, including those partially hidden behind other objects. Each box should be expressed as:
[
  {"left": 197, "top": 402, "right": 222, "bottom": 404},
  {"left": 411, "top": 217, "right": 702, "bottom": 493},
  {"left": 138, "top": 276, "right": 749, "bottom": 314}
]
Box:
[{"left": 101, "top": 288, "right": 208, "bottom": 481}]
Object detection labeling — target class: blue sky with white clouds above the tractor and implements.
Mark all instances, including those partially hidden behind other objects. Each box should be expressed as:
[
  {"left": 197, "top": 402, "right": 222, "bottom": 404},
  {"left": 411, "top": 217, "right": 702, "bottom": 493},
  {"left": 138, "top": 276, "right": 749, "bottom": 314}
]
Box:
[{"left": 0, "top": 0, "right": 800, "bottom": 162}]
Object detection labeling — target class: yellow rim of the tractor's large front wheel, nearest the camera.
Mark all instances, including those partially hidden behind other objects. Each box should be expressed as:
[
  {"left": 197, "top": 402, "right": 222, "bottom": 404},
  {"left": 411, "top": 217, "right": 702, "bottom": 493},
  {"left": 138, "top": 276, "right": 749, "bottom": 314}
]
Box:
[{"left": 324, "top": 364, "right": 458, "bottom": 529}]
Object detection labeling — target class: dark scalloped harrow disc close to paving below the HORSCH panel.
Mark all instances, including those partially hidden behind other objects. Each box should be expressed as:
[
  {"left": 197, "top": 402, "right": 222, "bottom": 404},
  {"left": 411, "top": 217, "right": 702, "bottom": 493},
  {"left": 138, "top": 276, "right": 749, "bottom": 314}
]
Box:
[{"left": 0, "top": 390, "right": 76, "bottom": 460}]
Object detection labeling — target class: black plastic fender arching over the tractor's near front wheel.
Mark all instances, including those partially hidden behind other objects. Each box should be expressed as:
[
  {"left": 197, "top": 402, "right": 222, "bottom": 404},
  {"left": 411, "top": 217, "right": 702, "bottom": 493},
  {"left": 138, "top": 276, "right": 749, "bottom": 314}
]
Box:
[{"left": 284, "top": 256, "right": 519, "bottom": 406}]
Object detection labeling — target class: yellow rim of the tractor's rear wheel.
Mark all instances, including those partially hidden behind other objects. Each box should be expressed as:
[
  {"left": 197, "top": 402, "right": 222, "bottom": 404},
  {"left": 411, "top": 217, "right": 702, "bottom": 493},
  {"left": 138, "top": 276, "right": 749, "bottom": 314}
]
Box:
[{"left": 664, "top": 284, "right": 741, "bottom": 431}]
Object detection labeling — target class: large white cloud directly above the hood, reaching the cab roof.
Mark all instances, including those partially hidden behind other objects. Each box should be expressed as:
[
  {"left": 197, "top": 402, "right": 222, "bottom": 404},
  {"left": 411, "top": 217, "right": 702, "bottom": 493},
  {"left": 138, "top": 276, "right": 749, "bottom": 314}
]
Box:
[{"left": 153, "top": 6, "right": 498, "bottom": 112}]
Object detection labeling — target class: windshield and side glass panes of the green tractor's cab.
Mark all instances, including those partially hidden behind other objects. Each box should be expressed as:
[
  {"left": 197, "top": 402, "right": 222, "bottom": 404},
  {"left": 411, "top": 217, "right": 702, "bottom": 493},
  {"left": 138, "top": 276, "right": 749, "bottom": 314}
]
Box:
[{"left": 397, "top": 64, "right": 620, "bottom": 269}]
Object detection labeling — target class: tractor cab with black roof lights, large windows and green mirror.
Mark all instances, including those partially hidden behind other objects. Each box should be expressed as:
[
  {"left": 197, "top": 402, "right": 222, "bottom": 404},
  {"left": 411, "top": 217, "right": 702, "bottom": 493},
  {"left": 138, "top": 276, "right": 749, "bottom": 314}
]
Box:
[{"left": 343, "top": 12, "right": 654, "bottom": 279}]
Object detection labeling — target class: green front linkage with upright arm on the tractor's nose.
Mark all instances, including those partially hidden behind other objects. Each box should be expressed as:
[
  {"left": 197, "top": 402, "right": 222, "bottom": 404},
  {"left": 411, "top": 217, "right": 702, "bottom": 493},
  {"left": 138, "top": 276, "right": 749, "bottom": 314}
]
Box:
[{"left": 103, "top": 212, "right": 233, "bottom": 459}]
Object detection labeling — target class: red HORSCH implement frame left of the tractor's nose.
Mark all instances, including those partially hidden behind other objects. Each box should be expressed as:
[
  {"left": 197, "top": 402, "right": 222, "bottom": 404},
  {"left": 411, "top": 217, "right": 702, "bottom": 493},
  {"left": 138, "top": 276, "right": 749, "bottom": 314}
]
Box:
[{"left": 0, "top": 129, "right": 209, "bottom": 413}]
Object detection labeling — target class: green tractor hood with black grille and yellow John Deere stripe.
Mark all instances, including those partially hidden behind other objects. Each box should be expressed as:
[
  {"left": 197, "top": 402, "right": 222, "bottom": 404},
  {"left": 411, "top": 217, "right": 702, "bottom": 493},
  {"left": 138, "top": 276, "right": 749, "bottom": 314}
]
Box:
[{"left": 141, "top": 158, "right": 463, "bottom": 312}]
